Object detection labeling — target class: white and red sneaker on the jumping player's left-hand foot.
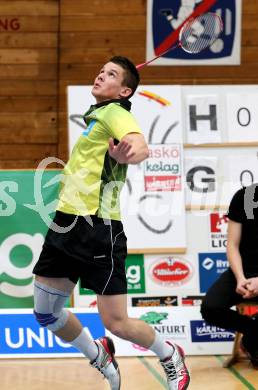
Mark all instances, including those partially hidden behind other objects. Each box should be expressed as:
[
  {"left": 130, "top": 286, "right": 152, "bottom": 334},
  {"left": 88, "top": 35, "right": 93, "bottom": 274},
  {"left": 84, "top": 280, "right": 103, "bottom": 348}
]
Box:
[{"left": 90, "top": 337, "right": 121, "bottom": 390}]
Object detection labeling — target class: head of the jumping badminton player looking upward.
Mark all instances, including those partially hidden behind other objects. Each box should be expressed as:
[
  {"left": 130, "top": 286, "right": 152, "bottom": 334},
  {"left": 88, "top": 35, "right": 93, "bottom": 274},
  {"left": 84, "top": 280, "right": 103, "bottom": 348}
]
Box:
[{"left": 92, "top": 56, "right": 140, "bottom": 103}]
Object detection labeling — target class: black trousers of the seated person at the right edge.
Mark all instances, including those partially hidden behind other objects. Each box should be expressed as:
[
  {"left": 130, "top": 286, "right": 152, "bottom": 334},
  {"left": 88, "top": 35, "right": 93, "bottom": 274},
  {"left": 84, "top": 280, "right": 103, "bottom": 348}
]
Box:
[{"left": 201, "top": 269, "right": 258, "bottom": 339}]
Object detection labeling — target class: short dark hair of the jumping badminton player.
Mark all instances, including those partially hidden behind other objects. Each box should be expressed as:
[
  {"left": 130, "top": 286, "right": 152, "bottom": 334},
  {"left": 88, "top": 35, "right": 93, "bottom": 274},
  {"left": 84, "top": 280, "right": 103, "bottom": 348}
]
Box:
[{"left": 109, "top": 56, "right": 140, "bottom": 98}]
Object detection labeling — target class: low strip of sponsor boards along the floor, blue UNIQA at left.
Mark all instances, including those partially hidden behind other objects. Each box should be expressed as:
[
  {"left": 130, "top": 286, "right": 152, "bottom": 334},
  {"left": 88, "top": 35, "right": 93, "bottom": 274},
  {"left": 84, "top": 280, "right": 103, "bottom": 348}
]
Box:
[{"left": 0, "top": 306, "right": 232, "bottom": 358}]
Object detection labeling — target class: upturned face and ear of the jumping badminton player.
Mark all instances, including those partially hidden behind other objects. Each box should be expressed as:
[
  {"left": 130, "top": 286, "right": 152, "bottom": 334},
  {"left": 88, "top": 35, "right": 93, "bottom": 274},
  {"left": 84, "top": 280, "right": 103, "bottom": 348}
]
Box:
[{"left": 91, "top": 62, "right": 132, "bottom": 103}]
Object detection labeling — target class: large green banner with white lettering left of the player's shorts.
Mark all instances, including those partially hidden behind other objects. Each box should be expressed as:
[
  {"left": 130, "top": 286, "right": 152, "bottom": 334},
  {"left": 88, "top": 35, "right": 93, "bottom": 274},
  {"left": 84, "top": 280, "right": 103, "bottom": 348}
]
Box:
[{"left": 0, "top": 170, "right": 60, "bottom": 308}]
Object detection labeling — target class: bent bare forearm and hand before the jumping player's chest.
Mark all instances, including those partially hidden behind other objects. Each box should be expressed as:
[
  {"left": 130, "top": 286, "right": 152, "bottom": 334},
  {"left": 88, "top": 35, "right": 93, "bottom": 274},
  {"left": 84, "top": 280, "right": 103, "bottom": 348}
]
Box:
[{"left": 108, "top": 133, "right": 149, "bottom": 164}]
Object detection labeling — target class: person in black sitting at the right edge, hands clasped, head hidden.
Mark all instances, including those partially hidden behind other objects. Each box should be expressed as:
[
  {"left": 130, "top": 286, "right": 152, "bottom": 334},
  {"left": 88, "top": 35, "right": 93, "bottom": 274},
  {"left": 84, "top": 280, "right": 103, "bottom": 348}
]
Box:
[{"left": 201, "top": 183, "right": 258, "bottom": 368}]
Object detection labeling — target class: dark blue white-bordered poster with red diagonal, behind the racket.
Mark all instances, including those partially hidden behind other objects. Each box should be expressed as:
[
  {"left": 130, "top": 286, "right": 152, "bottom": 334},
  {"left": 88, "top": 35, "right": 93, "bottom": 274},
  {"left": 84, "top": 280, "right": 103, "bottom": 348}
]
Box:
[{"left": 147, "top": 0, "right": 241, "bottom": 65}]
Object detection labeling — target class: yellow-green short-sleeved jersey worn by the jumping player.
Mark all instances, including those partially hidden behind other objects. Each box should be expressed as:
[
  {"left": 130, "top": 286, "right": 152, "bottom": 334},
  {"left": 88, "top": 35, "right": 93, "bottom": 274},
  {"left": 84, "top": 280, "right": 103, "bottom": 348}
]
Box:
[{"left": 57, "top": 99, "right": 141, "bottom": 220}]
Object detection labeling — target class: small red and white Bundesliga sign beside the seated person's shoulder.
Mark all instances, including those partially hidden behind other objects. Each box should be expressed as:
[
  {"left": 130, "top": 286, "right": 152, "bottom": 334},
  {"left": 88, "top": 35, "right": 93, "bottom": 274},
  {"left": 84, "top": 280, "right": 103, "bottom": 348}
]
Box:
[{"left": 209, "top": 213, "right": 228, "bottom": 250}]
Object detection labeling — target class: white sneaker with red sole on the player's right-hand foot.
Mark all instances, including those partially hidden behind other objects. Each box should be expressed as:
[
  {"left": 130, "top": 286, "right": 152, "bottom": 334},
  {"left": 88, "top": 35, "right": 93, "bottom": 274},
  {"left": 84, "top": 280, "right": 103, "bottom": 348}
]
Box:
[{"left": 160, "top": 341, "right": 190, "bottom": 390}]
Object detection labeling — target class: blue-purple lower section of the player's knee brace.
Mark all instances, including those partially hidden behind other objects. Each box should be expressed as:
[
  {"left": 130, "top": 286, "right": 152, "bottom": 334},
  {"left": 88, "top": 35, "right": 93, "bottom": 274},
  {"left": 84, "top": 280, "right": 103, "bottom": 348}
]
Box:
[{"left": 34, "top": 309, "right": 68, "bottom": 332}]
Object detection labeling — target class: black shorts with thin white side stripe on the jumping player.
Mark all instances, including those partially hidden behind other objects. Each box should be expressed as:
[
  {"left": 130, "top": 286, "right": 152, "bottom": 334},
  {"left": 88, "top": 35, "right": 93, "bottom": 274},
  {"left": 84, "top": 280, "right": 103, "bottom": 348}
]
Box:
[{"left": 33, "top": 211, "right": 127, "bottom": 295}]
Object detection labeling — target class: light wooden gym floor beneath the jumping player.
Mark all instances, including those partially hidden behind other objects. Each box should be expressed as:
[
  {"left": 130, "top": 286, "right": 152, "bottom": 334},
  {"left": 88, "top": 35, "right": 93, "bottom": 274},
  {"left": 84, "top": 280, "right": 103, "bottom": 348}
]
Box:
[{"left": 0, "top": 356, "right": 258, "bottom": 390}]
